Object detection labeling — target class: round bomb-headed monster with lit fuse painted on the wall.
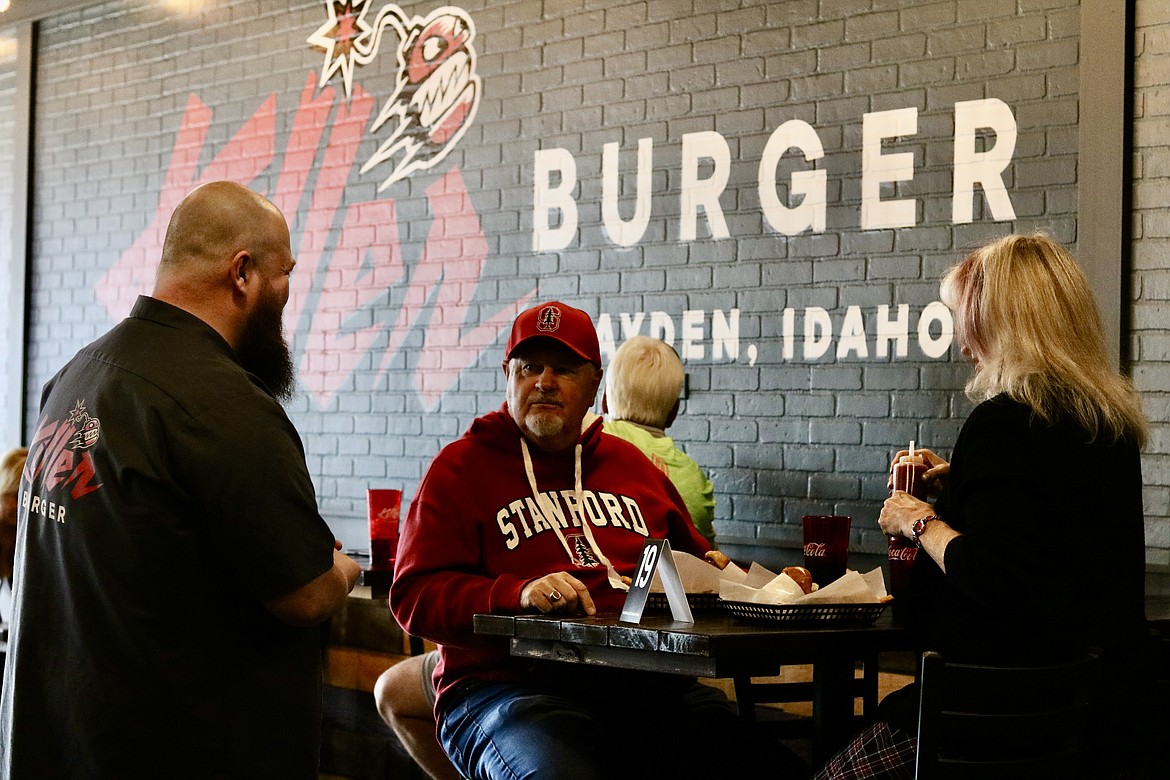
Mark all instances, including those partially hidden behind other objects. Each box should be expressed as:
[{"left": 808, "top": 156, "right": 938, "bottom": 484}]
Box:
[{"left": 308, "top": 0, "right": 482, "bottom": 192}]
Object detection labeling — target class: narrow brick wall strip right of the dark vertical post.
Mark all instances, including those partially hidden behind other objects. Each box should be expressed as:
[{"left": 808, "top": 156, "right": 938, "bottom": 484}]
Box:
[{"left": 1130, "top": 2, "right": 1170, "bottom": 565}]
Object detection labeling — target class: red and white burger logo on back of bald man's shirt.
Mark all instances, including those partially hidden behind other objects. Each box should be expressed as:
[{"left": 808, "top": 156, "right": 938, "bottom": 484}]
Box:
[{"left": 19, "top": 399, "right": 102, "bottom": 523}]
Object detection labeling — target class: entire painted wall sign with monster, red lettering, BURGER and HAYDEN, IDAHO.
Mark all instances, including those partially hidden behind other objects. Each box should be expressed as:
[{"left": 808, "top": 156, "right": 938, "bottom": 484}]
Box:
[{"left": 96, "top": 0, "right": 1019, "bottom": 412}]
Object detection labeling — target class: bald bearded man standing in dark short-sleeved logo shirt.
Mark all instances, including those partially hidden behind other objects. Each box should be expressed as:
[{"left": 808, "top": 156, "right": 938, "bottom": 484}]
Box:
[{"left": 0, "top": 181, "right": 360, "bottom": 779}]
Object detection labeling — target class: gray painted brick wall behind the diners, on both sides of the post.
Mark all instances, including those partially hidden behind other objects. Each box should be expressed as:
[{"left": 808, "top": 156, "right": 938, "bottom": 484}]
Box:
[{"left": 13, "top": 0, "right": 1170, "bottom": 568}]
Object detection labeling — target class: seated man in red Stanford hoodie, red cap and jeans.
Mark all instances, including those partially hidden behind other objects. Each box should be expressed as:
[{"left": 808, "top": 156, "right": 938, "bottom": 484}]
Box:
[{"left": 390, "top": 302, "right": 776, "bottom": 779}]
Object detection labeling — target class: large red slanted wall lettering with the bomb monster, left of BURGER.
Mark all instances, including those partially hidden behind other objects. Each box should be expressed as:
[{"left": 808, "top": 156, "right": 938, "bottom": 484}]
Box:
[{"left": 97, "top": 0, "right": 535, "bottom": 409}]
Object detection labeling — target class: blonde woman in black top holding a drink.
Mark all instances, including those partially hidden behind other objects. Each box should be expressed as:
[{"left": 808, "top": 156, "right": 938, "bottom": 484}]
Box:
[{"left": 819, "top": 235, "right": 1147, "bottom": 778}]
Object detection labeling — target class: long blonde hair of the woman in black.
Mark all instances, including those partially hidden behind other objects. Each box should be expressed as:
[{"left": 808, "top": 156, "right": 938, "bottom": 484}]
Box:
[{"left": 941, "top": 234, "right": 1148, "bottom": 447}]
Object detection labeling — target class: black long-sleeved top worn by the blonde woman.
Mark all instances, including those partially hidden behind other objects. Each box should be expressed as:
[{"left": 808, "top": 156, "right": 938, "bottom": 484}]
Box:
[{"left": 911, "top": 395, "right": 1145, "bottom": 668}]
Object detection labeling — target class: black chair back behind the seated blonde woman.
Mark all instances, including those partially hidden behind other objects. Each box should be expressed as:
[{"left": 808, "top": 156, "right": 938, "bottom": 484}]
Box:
[{"left": 916, "top": 651, "right": 1100, "bottom": 780}]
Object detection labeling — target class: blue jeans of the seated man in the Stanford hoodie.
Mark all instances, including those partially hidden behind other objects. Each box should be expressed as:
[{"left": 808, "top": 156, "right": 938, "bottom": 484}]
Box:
[{"left": 439, "top": 681, "right": 786, "bottom": 780}]
